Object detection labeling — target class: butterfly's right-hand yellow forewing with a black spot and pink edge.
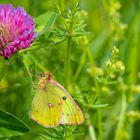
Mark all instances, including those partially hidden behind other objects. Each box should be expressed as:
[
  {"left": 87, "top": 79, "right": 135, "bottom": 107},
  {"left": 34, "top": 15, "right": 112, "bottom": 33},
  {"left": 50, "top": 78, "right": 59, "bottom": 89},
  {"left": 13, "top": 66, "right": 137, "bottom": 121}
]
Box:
[{"left": 48, "top": 80, "right": 84, "bottom": 124}]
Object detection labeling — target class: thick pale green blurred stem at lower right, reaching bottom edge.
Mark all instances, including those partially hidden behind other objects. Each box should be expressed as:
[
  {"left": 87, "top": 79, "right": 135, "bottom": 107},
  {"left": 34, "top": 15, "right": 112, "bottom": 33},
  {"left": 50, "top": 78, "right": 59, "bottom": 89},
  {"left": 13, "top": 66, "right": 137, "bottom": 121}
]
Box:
[{"left": 114, "top": 93, "right": 127, "bottom": 140}]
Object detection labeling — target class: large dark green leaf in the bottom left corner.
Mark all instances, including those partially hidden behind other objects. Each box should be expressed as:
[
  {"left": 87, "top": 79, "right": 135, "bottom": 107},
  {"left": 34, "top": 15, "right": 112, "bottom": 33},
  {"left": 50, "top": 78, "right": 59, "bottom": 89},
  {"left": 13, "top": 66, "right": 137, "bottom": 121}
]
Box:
[{"left": 0, "top": 109, "right": 30, "bottom": 137}]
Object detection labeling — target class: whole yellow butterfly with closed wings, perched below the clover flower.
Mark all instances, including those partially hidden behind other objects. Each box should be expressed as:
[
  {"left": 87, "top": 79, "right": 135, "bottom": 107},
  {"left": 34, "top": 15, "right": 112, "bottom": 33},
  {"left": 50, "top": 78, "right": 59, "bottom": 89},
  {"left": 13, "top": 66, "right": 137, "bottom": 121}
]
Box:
[{"left": 31, "top": 73, "right": 84, "bottom": 128}]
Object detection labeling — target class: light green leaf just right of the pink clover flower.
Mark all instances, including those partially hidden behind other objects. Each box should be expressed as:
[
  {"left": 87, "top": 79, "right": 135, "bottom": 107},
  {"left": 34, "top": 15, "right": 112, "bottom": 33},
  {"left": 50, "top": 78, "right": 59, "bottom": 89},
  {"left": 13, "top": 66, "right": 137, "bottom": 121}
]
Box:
[{"left": 35, "top": 11, "right": 57, "bottom": 36}]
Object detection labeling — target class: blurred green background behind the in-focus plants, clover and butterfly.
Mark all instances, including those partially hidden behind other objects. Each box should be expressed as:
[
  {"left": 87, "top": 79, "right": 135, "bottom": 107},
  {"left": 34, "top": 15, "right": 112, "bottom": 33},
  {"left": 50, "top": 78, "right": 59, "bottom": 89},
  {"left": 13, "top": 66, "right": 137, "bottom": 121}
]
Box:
[{"left": 0, "top": 0, "right": 140, "bottom": 140}]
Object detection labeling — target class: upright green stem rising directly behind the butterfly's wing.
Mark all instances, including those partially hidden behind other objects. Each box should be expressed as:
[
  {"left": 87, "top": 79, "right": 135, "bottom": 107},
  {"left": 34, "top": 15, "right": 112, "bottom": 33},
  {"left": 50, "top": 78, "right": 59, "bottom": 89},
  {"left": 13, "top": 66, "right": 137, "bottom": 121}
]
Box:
[{"left": 65, "top": 36, "right": 71, "bottom": 91}]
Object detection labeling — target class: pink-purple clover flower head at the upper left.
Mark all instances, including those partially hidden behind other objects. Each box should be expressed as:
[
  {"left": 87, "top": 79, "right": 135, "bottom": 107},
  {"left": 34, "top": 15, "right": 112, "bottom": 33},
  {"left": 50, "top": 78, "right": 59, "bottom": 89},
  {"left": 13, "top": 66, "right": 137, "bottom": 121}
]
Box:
[{"left": 0, "top": 4, "right": 37, "bottom": 59}]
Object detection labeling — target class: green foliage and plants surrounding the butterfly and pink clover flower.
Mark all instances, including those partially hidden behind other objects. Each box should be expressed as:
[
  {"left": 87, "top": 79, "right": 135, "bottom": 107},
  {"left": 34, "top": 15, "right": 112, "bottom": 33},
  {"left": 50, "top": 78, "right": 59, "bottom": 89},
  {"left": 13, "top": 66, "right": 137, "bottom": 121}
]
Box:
[{"left": 0, "top": 0, "right": 140, "bottom": 140}]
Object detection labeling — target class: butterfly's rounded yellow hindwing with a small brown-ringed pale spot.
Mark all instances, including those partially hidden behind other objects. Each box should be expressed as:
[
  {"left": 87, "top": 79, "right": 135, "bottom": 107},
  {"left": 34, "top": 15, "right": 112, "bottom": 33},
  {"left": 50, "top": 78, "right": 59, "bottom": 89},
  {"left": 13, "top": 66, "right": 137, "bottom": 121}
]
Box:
[{"left": 31, "top": 89, "right": 62, "bottom": 127}]
